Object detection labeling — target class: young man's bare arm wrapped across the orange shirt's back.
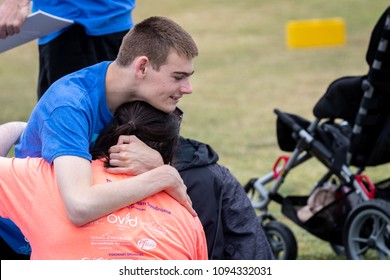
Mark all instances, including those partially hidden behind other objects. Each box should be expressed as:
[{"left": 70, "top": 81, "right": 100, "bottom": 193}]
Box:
[{"left": 54, "top": 156, "right": 196, "bottom": 226}]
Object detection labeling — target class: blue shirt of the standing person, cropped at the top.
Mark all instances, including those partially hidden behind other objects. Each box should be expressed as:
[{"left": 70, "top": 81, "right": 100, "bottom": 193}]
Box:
[{"left": 32, "top": 0, "right": 135, "bottom": 44}]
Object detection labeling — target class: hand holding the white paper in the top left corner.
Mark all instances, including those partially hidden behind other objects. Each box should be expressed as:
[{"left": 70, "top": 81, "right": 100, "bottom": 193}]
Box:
[{"left": 0, "top": 0, "right": 30, "bottom": 39}]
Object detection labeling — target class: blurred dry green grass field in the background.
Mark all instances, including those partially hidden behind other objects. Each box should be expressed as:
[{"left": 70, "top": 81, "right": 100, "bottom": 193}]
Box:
[{"left": 0, "top": 0, "right": 389, "bottom": 259}]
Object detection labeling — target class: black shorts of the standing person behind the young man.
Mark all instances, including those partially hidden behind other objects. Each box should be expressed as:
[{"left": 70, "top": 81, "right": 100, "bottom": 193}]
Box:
[{"left": 38, "top": 24, "right": 128, "bottom": 99}]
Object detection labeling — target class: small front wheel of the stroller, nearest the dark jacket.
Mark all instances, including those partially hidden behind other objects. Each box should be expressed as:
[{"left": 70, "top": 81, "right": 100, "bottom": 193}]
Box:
[{"left": 263, "top": 221, "right": 298, "bottom": 260}]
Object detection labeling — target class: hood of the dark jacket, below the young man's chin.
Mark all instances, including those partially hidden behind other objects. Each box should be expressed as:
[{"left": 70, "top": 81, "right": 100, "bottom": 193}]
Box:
[{"left": 173, "top": 137, "right": 219, "bottom": 171}]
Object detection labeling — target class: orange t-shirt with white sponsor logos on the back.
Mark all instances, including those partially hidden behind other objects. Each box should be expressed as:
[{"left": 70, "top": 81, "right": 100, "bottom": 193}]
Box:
[{"left": 0, "top": 158, "right": 207, "bottom": 260}]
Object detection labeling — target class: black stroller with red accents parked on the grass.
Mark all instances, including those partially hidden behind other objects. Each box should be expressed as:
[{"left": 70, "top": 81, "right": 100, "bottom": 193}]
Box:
[{"left": 245, "top": 7, "right": 390, "bottom": 259}]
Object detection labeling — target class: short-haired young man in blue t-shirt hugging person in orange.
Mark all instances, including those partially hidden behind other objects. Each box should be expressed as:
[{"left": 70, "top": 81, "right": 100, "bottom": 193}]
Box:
[{"left": 0, "top": 17, "right": 198, "bottom": 260}]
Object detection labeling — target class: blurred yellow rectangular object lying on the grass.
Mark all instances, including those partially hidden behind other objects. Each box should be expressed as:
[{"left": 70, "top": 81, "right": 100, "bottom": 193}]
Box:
[{"left": 286, "top": 18, "right": 346, "bottom": 48}]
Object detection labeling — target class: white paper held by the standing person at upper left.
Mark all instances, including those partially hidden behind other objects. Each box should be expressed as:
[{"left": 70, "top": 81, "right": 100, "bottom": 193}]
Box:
[{"left": 0, "top": 11, "right": 73, "bottom": 53}]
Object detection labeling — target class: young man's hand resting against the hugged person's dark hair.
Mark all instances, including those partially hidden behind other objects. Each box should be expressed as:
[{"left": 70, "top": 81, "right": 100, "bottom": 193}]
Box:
[{"left": 107, "top": 135, "right": 164, "bottom": 175}]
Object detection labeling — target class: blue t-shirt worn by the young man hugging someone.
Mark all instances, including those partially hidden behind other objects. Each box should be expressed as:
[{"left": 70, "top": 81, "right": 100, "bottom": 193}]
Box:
[{"left": 15, "top": 61, "right": 113, "bottom": 163}]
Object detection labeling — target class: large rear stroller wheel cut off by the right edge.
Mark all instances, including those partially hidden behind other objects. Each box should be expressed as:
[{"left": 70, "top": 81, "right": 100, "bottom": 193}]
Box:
[{"left": 343, "top": 199, "right": 390, "bottom": 260}]
